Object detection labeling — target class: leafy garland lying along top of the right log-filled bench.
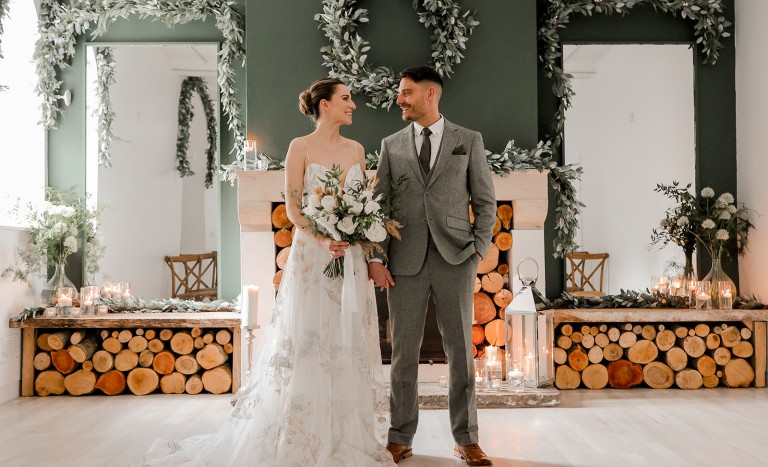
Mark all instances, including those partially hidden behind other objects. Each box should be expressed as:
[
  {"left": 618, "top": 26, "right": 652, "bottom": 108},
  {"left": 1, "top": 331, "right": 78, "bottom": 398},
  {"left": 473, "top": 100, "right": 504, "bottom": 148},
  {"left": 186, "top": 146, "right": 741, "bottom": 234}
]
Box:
[{"left": 551, "top": 289, "right": 768, "bottom": 312}]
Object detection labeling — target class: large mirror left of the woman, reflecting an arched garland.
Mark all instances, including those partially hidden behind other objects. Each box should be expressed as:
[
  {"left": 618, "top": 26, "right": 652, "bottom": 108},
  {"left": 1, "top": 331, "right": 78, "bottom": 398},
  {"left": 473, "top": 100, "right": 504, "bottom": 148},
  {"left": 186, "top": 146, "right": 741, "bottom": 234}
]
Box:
[{"left": 86, "top": 44, "right": 219, "bottom": 299}]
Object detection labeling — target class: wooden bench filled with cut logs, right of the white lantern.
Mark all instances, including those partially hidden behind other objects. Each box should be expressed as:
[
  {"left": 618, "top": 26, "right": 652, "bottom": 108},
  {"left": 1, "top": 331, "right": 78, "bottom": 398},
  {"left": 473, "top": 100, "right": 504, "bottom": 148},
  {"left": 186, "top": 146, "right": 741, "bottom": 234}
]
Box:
[{"left": 553, "top": 308, "right": 768, "bottom": 389}]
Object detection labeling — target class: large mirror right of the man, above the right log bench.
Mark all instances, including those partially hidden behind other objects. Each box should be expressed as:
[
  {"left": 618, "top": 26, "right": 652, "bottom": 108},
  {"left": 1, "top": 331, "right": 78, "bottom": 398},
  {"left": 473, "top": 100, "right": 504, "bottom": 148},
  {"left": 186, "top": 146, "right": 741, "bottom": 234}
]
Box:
[{"left": 563, "top": 44, "right": 696, "bottom": 294}]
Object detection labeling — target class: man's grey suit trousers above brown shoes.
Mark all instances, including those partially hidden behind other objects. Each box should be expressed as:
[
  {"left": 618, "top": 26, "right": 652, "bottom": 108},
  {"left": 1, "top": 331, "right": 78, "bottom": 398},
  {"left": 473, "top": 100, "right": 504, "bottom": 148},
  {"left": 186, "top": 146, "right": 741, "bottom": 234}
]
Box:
[{"left": 388, "top": 247, "right": 479, "bottom": 446}]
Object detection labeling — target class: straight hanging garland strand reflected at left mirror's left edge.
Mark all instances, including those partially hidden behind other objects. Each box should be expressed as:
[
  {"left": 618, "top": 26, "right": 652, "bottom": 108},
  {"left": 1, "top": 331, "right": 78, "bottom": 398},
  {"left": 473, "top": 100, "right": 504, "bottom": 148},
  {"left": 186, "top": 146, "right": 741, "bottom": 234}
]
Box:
[{"left": 93, "top": 47, "right": 115, "bottom": 167}]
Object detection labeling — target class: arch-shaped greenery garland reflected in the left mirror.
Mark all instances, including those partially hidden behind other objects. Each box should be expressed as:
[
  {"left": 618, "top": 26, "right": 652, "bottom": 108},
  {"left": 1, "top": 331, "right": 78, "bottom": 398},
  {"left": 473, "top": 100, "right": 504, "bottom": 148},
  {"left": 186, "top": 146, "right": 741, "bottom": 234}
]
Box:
[{"left": 176, "top": 76, "right": 218, "bottom": 188}]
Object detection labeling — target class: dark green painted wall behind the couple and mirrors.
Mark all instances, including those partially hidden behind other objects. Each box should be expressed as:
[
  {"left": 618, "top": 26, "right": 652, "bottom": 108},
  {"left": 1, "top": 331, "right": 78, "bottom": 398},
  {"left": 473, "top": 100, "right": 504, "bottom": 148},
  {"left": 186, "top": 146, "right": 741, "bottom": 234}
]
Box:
[{"left": 49, "top": 0, "right": 738, "bottom": 298}]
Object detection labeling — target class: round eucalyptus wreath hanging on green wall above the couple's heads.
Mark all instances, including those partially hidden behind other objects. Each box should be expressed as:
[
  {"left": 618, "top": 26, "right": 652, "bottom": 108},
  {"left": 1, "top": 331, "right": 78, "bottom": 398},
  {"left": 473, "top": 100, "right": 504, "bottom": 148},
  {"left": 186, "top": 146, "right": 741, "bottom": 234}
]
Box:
[{"left": 315, "top": 0, "right": 479, "bottom": 109}]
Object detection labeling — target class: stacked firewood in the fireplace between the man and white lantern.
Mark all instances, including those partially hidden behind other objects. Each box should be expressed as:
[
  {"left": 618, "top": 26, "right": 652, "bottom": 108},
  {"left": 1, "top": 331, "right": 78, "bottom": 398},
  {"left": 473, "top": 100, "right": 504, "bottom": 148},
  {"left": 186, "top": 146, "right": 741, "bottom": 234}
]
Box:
[{"left": 472, "top": 203, "right": 512, "bottom": 357}]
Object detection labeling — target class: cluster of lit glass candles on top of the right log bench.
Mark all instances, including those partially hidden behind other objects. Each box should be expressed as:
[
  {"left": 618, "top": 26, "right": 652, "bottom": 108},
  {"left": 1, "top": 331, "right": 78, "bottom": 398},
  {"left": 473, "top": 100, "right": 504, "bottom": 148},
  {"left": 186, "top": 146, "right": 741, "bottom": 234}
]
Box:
[{"left": 651, "top": 276, "right": 734, "bottom": 310}]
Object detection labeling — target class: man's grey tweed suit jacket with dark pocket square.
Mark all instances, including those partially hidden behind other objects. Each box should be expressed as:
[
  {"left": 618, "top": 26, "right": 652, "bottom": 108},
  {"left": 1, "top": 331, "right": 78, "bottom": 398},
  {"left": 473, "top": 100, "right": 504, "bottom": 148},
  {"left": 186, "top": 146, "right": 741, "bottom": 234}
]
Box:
[{"left": 377, "top": 120, "right": 496, "bottom": 276}]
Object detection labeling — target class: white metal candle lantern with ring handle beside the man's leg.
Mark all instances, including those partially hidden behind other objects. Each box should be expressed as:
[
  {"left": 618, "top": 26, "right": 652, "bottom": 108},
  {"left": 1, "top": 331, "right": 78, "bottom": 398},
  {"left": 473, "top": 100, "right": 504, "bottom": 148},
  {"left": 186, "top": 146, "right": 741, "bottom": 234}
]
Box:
[{"left": 504, "top": 258, "right": 555, "bottom": 389}]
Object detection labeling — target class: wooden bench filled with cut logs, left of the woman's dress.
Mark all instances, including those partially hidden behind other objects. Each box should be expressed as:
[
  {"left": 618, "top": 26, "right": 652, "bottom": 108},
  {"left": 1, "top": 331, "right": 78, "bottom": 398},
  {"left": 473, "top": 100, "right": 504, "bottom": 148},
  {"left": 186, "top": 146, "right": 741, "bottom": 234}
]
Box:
[{"left": 10, "top": 312, "right": 241, "bottom": 396}]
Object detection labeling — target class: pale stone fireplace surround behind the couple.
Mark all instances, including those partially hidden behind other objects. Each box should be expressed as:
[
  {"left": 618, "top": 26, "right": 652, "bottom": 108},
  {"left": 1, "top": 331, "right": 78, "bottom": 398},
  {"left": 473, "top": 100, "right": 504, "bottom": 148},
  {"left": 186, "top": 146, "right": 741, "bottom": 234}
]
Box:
[{"left": 237, "top": 170, "right": 548, "bottom": 323}]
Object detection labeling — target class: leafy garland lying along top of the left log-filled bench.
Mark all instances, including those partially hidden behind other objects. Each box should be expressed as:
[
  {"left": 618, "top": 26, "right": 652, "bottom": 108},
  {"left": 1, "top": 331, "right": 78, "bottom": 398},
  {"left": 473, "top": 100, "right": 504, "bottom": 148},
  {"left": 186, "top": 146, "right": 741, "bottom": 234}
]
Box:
[{"left": 11, "top": 297, "right": 240, "bottom": 323}]
